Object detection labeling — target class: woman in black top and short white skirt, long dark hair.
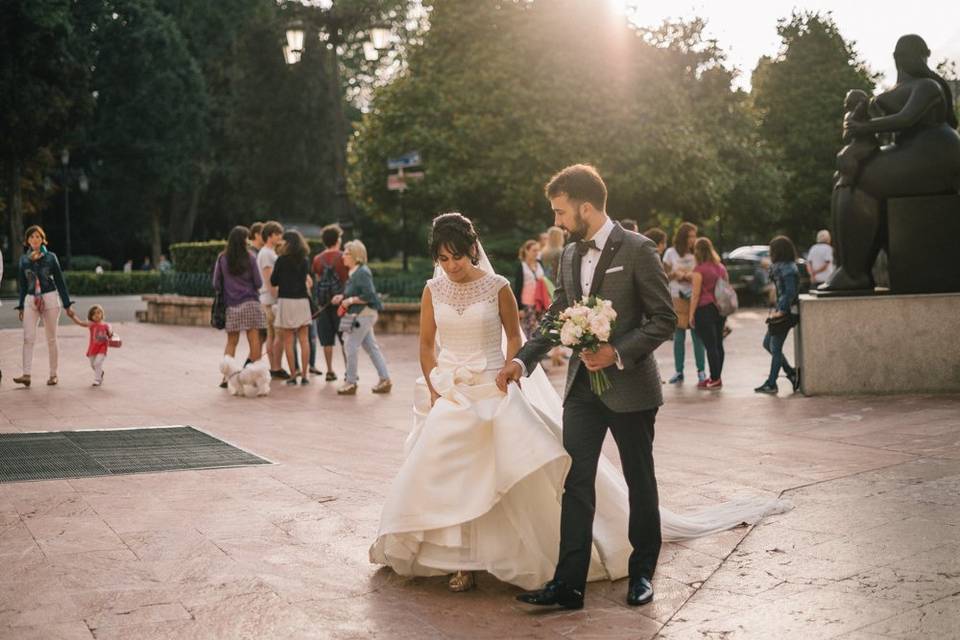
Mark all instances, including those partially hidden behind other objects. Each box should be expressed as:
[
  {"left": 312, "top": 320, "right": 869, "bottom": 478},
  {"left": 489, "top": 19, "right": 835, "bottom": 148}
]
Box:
[{"left": 270, "top": 231, "right": 313, "bottom": 385}]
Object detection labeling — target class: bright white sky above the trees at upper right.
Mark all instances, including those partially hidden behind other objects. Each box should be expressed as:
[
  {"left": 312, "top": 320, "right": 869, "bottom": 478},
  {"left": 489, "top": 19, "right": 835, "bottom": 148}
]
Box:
[{"left": 616, "top": 0, "right": 960, "bottom": 87}]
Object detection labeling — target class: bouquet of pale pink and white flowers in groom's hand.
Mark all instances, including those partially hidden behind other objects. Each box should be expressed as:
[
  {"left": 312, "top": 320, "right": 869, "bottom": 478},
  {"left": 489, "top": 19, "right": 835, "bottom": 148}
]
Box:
[{"left": 540, "top": 296, "right": 617, "bottom": 396}]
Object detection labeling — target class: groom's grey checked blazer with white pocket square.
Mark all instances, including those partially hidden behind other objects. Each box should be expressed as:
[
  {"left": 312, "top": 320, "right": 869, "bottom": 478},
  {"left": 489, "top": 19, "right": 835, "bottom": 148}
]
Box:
[{"left": 517, "top": 224, "right": 677, "bottom": 413}]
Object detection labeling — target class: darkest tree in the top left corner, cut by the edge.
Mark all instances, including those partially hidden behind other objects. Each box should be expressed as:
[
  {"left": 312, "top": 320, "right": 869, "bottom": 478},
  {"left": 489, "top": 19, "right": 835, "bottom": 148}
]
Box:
[{"left": 0, "top": 0, "right": 91, "bottom": 260}]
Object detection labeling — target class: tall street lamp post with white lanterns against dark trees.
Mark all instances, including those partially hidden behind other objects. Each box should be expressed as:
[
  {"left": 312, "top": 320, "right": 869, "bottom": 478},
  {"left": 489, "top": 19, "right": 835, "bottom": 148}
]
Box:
[{"left": 283, "top": 9, "right": 390, "bottom": 238}]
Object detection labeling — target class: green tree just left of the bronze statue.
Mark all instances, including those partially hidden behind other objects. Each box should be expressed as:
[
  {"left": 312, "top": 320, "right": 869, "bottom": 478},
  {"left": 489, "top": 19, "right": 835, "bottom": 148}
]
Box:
[{"left": 752, "top": 12, "right": 874, "bottom": 245}]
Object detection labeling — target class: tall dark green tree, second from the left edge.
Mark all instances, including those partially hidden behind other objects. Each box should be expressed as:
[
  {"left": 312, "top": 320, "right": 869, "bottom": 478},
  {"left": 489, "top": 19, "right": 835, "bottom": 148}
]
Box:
[{"left": 90, "top": 0, "right": 207, "bottom": 261}]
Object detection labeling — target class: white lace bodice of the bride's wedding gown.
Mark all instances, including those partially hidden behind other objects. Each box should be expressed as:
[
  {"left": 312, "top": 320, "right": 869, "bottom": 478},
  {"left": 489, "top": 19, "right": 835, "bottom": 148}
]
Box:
[{"left": 427, "top": 274, "right": 509, "bottom": 371}]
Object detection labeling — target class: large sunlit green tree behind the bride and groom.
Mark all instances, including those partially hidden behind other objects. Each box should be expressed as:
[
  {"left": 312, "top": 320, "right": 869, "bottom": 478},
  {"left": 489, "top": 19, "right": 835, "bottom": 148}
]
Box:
[{"left": 351, "top": 0, "right": 777, "bottom": 257}]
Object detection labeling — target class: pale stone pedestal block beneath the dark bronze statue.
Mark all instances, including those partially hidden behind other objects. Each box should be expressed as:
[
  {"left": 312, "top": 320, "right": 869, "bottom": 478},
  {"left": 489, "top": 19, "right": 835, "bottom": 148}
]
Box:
[{"left": 795, "top": 293, "right": 960, "bottom": 395}]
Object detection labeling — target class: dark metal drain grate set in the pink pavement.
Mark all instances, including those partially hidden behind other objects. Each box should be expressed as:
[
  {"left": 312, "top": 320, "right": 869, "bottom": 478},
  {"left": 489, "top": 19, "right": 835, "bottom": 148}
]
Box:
[{"left": 0, "top": 427, "right": 270, "bottom": 483}]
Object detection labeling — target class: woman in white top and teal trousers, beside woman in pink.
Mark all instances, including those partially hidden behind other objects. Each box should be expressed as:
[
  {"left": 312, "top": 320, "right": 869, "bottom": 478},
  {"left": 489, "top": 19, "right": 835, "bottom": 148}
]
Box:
[{"left": 663, "top": 222, "right": 707, "bottom": 384}]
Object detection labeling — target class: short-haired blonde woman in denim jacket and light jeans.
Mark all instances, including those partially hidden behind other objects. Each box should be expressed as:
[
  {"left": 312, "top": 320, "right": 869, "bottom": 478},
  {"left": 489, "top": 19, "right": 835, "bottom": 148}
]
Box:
[{"left": 331, "top": 240, "right": 393, "bottom": 395}]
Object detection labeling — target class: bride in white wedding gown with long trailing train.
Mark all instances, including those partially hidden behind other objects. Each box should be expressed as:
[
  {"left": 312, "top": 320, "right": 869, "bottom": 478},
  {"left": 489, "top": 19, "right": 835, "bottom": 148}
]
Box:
[{"left": 370, "top": 213, "right": 788, "bottom": 591}]
